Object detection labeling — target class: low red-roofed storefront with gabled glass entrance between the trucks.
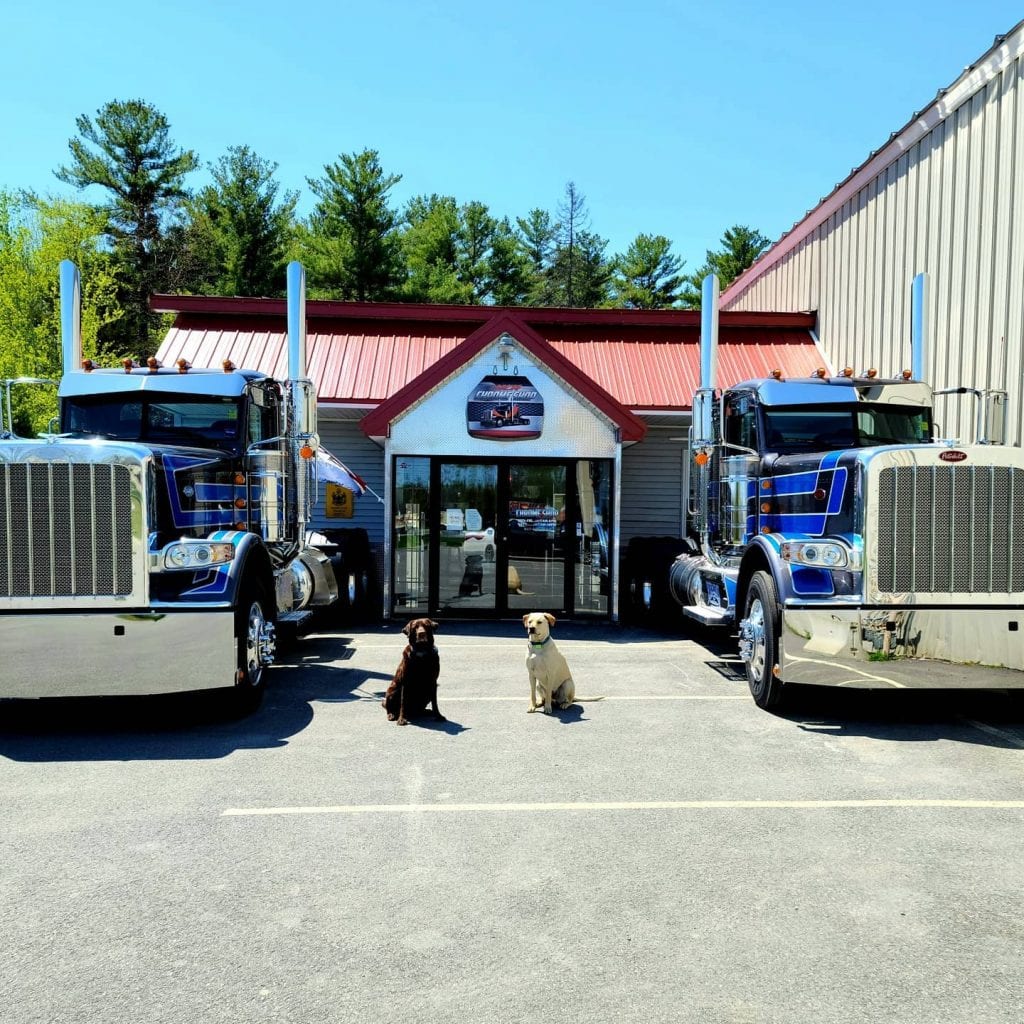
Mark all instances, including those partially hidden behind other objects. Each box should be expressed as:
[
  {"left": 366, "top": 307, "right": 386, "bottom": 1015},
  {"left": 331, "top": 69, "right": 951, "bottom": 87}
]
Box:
[{"left": 153, "top": 296, "right": 825, "bottom": 620}]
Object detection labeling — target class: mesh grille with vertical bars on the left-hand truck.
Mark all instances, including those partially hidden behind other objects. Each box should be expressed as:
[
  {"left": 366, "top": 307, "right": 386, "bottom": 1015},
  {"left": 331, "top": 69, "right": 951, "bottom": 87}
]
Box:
[{"left": 0, "top": 462, "right": 133, "bottom": 597}]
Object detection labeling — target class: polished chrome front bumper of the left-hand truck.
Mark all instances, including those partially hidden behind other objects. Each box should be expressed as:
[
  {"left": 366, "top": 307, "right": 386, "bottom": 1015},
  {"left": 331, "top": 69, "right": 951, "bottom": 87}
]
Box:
[{"left": 0, "top": 609, "right": 237, "bottom": 698}]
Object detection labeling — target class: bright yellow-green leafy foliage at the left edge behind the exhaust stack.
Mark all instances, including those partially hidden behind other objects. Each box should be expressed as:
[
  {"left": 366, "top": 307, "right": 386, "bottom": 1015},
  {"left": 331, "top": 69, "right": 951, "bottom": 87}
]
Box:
[{"left": 0, "top": 193, "right": 121, "bottom": 434}]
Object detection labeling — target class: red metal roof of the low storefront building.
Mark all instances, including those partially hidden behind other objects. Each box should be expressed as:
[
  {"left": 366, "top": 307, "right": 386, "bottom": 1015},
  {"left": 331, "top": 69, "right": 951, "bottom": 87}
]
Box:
[{"left": 151, "top": 296, "right": 823, "bottom": 422}]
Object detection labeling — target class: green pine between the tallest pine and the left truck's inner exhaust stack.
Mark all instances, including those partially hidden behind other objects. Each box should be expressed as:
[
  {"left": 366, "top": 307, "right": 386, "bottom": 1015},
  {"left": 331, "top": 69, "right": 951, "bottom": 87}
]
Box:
[{"left": 164, "top": 145, "right": 298, "bottom": 296}]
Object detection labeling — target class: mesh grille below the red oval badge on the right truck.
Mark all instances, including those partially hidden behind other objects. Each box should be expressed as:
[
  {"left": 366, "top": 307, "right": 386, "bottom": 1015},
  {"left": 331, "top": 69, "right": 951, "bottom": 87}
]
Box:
[{"left": 874, "top": 465, "right": 1024, "bottom": 594}]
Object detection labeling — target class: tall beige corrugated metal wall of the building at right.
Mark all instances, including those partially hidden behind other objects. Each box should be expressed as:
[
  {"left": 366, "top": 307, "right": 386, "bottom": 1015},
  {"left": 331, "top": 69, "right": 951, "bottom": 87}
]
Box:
[{"left": 724, "top": 28, "right": 1024, "bottom": 444}]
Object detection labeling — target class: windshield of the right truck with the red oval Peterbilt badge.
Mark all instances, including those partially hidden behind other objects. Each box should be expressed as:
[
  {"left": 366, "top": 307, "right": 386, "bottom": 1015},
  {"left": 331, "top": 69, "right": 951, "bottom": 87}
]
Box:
[{"left": 764, "top": 404, "right": 932, "bottom": 454}]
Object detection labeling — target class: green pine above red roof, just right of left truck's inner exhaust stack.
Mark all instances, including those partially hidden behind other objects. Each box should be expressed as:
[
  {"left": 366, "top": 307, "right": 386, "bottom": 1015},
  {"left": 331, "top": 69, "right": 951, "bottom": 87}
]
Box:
[{"left": 302, "top": 150, "right": 403, "bottom": 302}]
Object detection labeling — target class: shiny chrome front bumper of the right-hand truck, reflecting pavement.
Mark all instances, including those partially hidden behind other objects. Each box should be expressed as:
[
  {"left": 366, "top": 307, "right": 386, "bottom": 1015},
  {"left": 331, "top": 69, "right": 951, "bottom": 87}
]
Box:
[{"left": 779, "top": 605, "right": 1024, "bottom": 689}]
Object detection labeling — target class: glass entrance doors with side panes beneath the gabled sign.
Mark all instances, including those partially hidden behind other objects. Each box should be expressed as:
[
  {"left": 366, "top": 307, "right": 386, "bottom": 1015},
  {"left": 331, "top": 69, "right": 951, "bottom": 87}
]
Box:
[{"left": 393, "top": 457, "right": 611, "bottom": 617}]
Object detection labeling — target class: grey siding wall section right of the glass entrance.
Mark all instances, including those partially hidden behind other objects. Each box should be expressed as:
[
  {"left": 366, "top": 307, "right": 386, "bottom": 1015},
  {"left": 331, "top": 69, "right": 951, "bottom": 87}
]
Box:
[{"left": 618, "top": 424, "right": 687, "bottom": 551}]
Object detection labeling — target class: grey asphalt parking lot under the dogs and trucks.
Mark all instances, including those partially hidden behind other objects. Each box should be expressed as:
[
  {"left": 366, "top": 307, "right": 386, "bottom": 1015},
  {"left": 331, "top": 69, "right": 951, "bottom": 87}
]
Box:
[{"left": 0, "top": 623, "right": 1024, "bottom": 1024}]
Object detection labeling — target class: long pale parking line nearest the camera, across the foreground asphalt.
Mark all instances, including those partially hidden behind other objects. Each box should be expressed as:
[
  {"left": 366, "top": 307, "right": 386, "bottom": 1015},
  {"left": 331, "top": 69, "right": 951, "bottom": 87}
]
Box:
[{"left": 221, "top": 800, "right": 1024, "bottom": 817}]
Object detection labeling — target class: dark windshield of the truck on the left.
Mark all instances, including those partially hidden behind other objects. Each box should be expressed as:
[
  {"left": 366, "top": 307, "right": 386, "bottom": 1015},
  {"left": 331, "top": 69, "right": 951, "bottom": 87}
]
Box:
[{"left": 61, "top": 392, "right": 243, "bottom": 452}]
